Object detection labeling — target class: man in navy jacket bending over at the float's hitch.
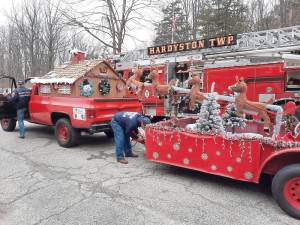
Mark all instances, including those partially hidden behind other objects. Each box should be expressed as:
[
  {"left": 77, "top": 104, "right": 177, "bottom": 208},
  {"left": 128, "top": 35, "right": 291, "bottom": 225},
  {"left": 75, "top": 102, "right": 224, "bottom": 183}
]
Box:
[{"left": 111, "top": 112, "right": 150, "bottom": 164}]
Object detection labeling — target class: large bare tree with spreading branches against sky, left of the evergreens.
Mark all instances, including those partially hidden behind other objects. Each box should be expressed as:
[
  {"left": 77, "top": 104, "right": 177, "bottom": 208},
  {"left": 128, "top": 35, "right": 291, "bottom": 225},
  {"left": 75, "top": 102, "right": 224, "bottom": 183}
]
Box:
[{"left": 64, "top": 0, "right": 154, "bottom": 54}]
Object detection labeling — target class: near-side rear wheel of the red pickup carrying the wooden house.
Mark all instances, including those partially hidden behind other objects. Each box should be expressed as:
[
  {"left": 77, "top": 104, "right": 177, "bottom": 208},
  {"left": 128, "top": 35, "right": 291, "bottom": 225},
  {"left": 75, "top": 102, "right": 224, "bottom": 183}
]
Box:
[{"left": 55, "top": 118, "right": 79, "bottom": 148}]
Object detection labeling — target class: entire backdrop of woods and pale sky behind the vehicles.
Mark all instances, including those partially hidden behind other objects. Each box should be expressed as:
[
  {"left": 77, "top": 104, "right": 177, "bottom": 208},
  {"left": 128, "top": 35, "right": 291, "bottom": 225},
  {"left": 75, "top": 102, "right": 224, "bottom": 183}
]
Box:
[{"left": 0, "top": 0, "right": 300, "bottom": 79}]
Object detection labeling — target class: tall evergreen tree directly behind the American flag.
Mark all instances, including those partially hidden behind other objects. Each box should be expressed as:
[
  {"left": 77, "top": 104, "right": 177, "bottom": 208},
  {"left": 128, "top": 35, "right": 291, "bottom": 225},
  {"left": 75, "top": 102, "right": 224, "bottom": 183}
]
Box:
[{"left": 154, "top": 0, "right": 190, "bottom": 45}]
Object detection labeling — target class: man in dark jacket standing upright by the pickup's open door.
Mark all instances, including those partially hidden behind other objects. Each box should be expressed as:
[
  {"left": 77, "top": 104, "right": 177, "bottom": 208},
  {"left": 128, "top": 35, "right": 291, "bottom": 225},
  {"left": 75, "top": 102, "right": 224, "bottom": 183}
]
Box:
[{"left": 9, "top": 80, "right": 31, "bottom": 138}]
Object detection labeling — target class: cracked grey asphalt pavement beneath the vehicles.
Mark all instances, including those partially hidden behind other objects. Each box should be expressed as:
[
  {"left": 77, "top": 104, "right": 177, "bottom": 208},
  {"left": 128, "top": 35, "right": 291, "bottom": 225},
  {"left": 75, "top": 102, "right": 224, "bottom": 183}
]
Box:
[{"left": 0, "top": 124, "right": 300, "bottom": 225}]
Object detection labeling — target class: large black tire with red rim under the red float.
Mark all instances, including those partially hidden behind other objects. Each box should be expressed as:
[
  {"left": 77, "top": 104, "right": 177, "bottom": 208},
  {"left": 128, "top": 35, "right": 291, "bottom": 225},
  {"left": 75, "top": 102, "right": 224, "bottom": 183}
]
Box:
[{"left": 272, "top": 164, "right": 300, "bottom": 219}]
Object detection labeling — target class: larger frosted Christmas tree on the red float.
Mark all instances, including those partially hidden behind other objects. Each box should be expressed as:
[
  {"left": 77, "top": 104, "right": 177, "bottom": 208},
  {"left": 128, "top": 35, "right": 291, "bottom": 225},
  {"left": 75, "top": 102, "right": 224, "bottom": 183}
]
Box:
[{"left": 196, "top": 93, "right": 225, "bottom": 134}]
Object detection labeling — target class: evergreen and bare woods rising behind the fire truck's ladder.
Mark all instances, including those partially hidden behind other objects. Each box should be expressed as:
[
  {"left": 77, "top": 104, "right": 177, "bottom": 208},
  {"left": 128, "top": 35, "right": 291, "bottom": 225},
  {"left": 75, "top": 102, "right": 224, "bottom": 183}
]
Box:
[{"left": 154, "top": 0, "right": 300, "bottom": 45}]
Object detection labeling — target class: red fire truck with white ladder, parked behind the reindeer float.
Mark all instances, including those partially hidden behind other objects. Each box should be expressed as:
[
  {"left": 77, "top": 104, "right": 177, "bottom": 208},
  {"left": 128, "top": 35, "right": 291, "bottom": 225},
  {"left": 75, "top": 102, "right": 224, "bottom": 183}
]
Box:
[{"left": 116, "top": 26, "right": 300, "bottom": 118}]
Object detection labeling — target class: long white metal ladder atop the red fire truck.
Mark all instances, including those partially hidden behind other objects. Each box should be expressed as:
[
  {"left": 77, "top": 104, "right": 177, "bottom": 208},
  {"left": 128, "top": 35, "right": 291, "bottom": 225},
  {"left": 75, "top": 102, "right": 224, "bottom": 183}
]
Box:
[{"left": 121, "top": 26, "right": 300, "bottom": 62}]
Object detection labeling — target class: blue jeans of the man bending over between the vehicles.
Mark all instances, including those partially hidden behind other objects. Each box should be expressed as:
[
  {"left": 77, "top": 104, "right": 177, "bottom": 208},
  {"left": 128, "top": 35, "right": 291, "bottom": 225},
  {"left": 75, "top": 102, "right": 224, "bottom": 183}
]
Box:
[{"left": 111, "top": 118, "right": 132, "bottom": 160}]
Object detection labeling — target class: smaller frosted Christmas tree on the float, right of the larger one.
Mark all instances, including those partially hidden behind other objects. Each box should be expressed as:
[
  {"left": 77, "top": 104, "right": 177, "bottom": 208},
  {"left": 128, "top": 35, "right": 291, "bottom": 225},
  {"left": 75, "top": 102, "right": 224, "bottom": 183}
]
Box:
[{"left": 223, "top": 103, "right": 246, "bottom": 133}]
